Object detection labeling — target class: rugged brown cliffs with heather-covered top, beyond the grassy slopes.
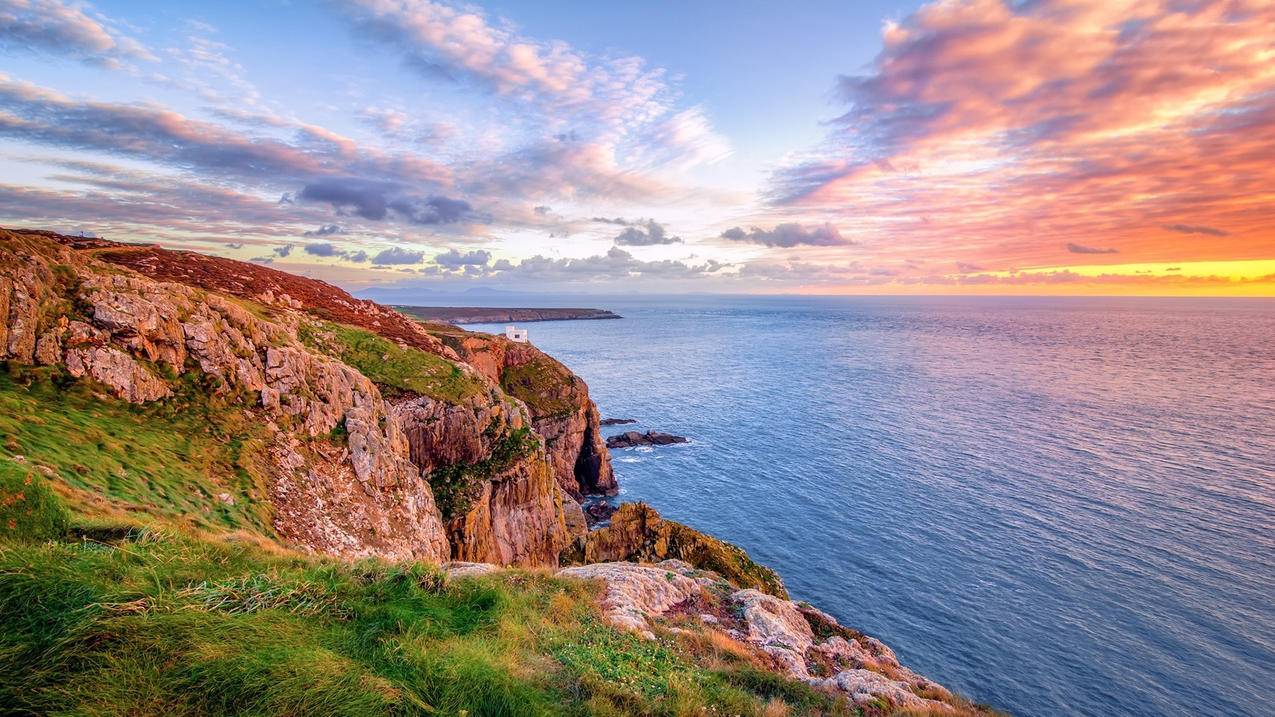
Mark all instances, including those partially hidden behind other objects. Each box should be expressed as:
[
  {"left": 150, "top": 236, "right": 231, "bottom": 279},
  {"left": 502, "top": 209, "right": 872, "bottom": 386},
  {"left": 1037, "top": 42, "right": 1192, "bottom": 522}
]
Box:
[{"left": 0, "top": 227, "right": 594, "bottom": 565}]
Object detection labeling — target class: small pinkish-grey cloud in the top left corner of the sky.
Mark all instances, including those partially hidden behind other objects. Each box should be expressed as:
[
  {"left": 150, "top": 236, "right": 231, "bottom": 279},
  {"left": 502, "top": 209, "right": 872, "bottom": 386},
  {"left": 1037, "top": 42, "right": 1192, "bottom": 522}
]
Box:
[{"left": 0, "top": 0, "right": 156, "bottom": 66}]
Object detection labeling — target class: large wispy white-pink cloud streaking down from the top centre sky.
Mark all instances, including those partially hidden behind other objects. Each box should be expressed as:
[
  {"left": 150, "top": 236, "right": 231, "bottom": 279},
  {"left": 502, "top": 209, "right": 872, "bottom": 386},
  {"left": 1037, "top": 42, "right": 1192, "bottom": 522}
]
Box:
[{"left": 337, "top": 0, "right": 729, "bottom": 196}]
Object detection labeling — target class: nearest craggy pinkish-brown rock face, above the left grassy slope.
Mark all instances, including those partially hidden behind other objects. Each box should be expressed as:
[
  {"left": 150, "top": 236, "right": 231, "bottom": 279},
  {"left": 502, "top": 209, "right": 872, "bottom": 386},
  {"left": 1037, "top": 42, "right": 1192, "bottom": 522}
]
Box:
[{"left": 0, "top": 225, "right": 449, "bottom": 560}]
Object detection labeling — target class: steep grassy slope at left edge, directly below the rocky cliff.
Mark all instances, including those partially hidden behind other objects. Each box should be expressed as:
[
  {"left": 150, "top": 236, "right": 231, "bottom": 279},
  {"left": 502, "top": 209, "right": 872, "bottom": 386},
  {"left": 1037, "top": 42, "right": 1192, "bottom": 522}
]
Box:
[{"left": 0, "top": 364, "right": 273, "bottom": 536}]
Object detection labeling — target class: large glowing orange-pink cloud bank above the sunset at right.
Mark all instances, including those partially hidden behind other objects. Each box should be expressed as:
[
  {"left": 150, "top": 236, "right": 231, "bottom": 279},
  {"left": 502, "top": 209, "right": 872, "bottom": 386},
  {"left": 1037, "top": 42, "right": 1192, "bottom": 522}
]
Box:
[{"left": 770, "top": 0, "right": 1275, "bottom": 286}]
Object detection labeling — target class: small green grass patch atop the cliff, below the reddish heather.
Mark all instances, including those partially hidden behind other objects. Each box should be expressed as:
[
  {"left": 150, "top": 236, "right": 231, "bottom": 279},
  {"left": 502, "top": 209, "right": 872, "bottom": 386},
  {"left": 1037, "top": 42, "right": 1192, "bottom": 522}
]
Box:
[{"left": 300, "top": 322, "right": 486, "bottom": 404}]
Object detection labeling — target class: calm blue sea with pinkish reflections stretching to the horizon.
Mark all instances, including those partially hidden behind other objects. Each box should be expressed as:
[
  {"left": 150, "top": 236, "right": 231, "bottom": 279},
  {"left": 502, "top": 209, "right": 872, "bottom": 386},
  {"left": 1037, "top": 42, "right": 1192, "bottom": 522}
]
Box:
[{"left": 464, "top": 299, "right": 1275, "bottom": 716}]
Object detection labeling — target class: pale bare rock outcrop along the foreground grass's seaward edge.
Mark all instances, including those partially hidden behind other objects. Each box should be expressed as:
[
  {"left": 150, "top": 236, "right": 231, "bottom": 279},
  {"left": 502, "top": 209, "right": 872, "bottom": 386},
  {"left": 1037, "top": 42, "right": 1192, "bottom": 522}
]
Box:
[{"left": 557, "top": 560, "right": 964, "bottom": 714}]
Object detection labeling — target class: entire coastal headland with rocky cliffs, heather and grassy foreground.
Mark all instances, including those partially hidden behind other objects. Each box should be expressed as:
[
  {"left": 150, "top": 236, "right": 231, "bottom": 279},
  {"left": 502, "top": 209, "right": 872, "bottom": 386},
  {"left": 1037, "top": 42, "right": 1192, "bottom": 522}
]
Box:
[{"left": 0, "top": 230, "right": 986, "bottom": 714}]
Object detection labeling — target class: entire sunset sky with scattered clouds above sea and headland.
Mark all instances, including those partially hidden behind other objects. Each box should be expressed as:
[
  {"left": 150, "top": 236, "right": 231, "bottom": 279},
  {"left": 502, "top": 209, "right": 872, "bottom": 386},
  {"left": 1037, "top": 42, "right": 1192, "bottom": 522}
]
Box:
[{"left": 0, "top": 0, "right": 1275, "bottom": 299}]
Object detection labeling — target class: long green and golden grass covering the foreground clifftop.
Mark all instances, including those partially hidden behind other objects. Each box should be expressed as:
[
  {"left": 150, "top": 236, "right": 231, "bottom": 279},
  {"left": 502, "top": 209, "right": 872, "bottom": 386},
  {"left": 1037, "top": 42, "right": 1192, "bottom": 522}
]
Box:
[{"left": 0, "top": 502, "right": 867, "bottom": 717}]
